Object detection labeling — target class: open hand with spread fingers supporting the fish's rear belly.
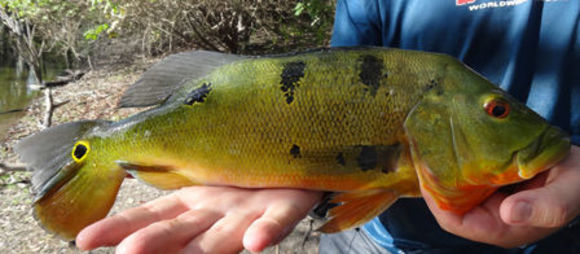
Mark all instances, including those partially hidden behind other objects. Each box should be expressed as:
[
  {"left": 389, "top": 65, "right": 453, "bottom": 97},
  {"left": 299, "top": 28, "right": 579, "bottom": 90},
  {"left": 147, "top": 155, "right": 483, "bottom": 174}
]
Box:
[{"left": 76, "top": 186, "right": 322, "bottom": 253}]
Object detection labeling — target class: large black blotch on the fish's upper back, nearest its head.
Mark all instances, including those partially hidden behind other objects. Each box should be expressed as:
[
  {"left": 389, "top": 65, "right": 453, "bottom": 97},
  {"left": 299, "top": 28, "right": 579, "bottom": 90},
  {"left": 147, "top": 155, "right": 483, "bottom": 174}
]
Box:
[{"left": 358, "top": 55, "right": 388, "bottom": 97}]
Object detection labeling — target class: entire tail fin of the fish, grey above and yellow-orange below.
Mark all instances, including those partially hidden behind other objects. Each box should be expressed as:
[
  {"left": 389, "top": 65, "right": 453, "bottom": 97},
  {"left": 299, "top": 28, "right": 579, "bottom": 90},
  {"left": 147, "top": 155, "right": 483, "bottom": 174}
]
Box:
[{"left": 14, "top": 121, "right": 125, "bottom": 240}]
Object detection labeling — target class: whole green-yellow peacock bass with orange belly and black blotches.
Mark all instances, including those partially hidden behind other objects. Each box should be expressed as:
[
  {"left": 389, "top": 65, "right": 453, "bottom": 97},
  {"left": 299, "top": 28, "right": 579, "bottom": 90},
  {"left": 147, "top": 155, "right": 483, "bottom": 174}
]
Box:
[{"left": 15, "top": 48, "right": 570, "bottom": 239}]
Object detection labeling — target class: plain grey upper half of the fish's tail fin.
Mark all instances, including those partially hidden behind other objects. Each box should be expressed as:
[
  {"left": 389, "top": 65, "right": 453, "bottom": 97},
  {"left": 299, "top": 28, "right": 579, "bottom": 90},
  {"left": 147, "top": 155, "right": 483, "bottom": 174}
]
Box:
[{"left": 14, "top": 120, "right": 110, "bottom": 195}]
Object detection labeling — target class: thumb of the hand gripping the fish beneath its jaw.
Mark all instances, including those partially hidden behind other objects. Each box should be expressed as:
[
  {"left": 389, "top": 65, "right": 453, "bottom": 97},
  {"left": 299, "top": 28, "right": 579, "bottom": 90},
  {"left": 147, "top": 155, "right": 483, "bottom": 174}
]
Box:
[{"left": 500, "top": 147, "right": 580, "bottom": 227}]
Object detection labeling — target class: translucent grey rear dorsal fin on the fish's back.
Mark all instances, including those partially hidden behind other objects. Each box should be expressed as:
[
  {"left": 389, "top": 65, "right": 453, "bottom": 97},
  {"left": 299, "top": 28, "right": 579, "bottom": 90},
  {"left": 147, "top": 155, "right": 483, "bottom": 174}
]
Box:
[{"left": 119, "top": 50, "right": 249, "bottom": 107}]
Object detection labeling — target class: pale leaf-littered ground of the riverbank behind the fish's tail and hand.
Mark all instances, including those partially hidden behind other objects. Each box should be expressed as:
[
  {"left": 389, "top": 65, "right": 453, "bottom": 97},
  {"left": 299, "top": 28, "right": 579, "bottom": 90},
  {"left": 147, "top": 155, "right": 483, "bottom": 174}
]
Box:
[{"left": 0, "top": 56, "right": 318, "bottom": 253}]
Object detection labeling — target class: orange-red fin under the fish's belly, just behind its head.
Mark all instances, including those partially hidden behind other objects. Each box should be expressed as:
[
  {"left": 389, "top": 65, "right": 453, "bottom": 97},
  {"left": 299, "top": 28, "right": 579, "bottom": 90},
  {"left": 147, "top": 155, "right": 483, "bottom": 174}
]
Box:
[{"left": 318, "top": 189, "right": 399, "bottom": 233}]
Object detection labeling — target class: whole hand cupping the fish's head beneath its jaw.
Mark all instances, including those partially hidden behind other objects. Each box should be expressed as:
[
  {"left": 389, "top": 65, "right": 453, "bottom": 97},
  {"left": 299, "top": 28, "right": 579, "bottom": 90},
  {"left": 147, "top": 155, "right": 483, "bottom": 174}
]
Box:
[{"left": 421, "top": 146, "right": 580, "bottom": 248}]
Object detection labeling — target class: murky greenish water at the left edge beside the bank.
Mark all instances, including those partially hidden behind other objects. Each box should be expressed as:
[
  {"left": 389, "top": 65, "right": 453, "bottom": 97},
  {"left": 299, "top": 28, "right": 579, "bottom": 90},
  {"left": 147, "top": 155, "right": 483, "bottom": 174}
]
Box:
[{"left": 0, "top": 63, "right": 63, "bottom": 140}]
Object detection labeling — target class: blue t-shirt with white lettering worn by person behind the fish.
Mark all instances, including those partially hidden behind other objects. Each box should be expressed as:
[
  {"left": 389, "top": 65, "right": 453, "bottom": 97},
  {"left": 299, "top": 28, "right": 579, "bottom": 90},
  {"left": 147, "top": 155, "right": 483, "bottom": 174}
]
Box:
[{"left": 331, "top": 0, "right": 580, "bottom": 253}]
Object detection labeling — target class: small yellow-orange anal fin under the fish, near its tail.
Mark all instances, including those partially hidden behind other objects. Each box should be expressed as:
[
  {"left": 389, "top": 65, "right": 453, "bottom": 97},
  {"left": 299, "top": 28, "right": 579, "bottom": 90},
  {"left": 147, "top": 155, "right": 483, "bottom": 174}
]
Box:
[{"left": 116, "top": 161, "right": 198, "bottom": 190}]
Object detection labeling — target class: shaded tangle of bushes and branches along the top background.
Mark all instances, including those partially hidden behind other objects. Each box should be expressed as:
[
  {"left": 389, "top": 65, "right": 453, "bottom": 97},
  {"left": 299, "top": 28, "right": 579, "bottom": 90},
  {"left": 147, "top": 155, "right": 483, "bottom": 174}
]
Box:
[{"left": 0, "top": 0, "right": 334, "bottom": 74}]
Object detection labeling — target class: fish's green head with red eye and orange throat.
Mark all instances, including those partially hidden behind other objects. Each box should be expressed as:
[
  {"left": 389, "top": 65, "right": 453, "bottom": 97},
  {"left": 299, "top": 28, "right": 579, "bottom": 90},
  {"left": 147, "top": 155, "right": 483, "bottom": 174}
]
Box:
[{"left": 405, "top": 61, "right": 570, "bottom": 213}]
